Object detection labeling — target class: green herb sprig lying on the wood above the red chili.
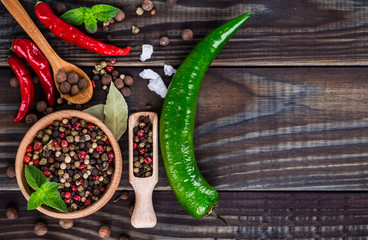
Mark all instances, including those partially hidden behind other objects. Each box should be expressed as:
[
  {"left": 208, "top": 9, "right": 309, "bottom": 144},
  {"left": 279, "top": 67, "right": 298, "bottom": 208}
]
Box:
[{"left": 61, "top": 4, "right": 119, "bottom": 33}]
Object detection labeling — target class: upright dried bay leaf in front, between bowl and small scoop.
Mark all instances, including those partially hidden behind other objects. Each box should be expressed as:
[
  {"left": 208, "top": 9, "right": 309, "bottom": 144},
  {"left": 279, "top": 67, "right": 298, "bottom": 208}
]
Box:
[{"left": 104, "top": 83, "right": 128, "bottom": 140}]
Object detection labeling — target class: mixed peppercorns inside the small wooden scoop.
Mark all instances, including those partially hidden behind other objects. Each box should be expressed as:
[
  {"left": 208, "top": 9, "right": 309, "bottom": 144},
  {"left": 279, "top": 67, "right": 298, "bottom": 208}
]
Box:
[{"left": 133, "top": 116, "right": 153, "bottom": 177}]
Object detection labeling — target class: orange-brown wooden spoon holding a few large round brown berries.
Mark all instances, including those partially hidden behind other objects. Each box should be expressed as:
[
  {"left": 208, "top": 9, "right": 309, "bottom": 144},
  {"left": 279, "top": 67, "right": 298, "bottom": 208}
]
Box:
[{"left": 1, "top": 0, "right": 93, "bottom": 104}]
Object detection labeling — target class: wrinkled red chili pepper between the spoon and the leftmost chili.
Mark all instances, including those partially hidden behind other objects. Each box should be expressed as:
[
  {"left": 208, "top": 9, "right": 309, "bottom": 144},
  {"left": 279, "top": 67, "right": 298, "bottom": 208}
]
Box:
[{"left": 13, "top": 39, "right": 56, "bottom": 107}]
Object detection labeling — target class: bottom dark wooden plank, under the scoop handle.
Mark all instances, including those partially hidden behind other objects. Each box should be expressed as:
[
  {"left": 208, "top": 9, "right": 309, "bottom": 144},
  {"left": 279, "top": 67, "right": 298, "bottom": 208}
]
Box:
[{"left": 0, "top": 191, "right": 368, "bottom": 240}]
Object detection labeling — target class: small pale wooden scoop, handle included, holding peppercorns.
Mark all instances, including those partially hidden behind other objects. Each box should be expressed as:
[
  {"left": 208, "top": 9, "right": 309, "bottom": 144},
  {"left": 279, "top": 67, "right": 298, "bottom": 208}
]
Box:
[{"left": 129, "top": 112, "right": 158, "bottom": 228}]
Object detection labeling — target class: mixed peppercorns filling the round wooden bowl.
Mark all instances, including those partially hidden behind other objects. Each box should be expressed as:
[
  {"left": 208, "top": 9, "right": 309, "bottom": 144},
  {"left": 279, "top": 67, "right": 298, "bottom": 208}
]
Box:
[{"left": 24, "top": 117, "right": 115, "bottom": 211}]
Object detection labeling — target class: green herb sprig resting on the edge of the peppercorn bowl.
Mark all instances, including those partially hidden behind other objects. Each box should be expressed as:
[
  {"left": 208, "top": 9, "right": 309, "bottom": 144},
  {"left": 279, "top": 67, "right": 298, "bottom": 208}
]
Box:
[{"left": 25, "top": 165, "right": 68, "bottom": 213}]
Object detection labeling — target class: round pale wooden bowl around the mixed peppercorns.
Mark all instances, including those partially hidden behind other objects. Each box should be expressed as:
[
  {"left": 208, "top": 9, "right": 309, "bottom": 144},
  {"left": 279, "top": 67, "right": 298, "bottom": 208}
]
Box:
[{"left": 15, "top": 110, "right": 123, "bottom": 219}]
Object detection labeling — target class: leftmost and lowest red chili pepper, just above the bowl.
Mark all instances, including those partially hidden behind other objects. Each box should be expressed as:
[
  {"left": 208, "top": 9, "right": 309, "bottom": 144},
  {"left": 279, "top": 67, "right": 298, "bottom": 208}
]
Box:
[{"left": 8, "top": 56, "right": 34, "bottom": 122}]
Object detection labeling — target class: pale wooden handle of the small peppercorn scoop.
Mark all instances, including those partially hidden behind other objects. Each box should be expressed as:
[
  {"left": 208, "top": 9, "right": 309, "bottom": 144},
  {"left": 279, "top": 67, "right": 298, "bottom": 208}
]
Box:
[{"left": 131, "top": 184, "right": 157, "bottom": 228}]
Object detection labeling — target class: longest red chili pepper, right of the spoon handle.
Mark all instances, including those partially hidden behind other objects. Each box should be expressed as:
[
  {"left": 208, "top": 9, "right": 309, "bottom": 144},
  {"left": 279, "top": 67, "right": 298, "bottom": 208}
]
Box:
[{"left": 35, "top": 3, "right": 130, "bottom": 56}]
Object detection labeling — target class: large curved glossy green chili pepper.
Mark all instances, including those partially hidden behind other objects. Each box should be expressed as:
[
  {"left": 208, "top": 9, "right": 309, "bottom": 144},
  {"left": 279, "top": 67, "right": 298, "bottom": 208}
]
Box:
[{"left": 160, "top": 13, "right": 252, "bottom": 218}]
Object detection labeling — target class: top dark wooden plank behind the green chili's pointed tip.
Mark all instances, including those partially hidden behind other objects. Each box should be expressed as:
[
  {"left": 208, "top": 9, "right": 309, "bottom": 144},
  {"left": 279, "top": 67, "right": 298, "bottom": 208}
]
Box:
[{"left": 0, "top": 0, "right": 368, "bottom": 66}]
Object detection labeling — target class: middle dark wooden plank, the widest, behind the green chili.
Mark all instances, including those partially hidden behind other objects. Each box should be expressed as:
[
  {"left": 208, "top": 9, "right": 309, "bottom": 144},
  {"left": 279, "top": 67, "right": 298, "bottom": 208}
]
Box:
[{"left": 0, "top": 68, "right": 368, "bottom": 191}]
